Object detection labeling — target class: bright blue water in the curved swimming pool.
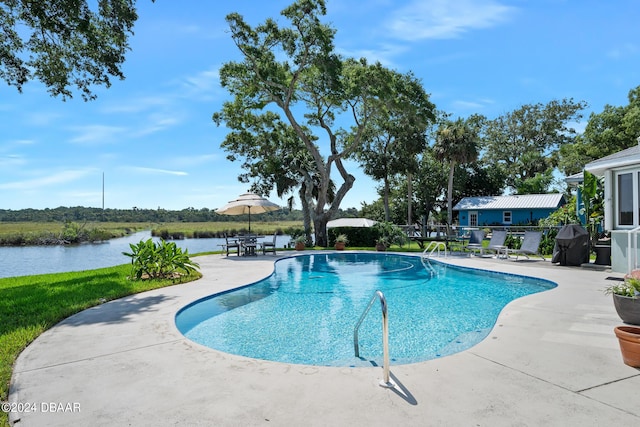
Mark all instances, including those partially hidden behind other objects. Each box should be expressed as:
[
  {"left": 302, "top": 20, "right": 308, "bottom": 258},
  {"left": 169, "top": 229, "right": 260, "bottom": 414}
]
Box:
[{"left": 176, "top": 253, "right": 556, "bottom": 366}]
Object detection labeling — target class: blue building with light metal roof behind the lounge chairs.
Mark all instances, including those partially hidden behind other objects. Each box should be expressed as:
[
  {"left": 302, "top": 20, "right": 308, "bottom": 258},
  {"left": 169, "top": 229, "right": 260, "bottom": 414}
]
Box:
[{"left": 453, "top": 193, "right": 566, "bottom": 227}]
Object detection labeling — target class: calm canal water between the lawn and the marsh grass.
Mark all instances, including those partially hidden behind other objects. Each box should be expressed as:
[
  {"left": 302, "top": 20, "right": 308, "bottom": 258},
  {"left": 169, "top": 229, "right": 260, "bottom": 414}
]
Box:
[{"left": 0, "top": 231, "right": 291, "bottom": 278}]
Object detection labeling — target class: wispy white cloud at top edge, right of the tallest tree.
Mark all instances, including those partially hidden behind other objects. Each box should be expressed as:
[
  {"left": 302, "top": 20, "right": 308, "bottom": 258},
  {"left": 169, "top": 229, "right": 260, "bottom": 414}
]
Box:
[{"left": 388, "top": 0, "right": 515, "bottom": 41}]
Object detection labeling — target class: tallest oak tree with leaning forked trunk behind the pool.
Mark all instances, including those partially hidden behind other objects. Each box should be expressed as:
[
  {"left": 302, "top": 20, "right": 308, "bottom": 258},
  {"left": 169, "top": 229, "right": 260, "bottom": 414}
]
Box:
[{"left": 213, "top": 0, "right": 430, "bottom": 246}]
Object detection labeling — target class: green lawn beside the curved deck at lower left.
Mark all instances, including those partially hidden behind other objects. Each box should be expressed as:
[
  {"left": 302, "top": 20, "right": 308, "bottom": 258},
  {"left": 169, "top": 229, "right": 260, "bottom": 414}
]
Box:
[{"left": 0, "top": 264, "right": 201, "bottom": 426}]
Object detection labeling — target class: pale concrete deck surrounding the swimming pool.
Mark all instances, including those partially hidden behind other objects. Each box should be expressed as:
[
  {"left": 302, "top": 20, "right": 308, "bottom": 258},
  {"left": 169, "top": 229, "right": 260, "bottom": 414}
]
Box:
[{"left": 9, "top": 252, "right": 640, "bottom": 427}]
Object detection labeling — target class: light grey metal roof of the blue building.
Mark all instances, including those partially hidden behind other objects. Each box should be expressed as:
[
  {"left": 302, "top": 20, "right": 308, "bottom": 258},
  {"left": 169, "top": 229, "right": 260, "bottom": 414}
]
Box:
[{"left": 453, "top": 193, "right": 564, "bottom": 211}]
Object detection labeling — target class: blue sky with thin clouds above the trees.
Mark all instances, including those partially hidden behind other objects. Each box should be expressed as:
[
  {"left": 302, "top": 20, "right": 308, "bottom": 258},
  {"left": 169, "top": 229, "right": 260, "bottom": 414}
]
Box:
[{"left": 0, "top": 0, "right": 640, "bottom": 209}]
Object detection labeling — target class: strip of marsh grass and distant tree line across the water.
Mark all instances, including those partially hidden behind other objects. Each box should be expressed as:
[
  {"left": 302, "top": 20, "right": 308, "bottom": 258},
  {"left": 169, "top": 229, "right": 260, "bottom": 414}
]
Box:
[{"left": 0, "top": 207, "right": 358, "bottom": 246}]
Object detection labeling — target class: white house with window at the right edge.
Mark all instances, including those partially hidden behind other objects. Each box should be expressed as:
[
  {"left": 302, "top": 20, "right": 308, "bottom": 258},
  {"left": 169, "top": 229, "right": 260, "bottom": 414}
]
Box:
[{"left": 584, "top": 138, "right": 640, "bottom": 273}]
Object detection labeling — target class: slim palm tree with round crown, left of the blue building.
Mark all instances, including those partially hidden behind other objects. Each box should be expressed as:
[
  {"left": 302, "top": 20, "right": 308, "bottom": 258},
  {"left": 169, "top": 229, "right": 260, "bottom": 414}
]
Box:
[{"left": 433, "top": 118, "right": 479, "bottom": 225}]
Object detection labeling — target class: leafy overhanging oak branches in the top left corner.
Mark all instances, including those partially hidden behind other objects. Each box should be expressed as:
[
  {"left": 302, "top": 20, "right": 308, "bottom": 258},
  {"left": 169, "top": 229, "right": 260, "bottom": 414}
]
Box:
[{"left": 0, "top": 0, "right": 144, "bottom": 100}]
